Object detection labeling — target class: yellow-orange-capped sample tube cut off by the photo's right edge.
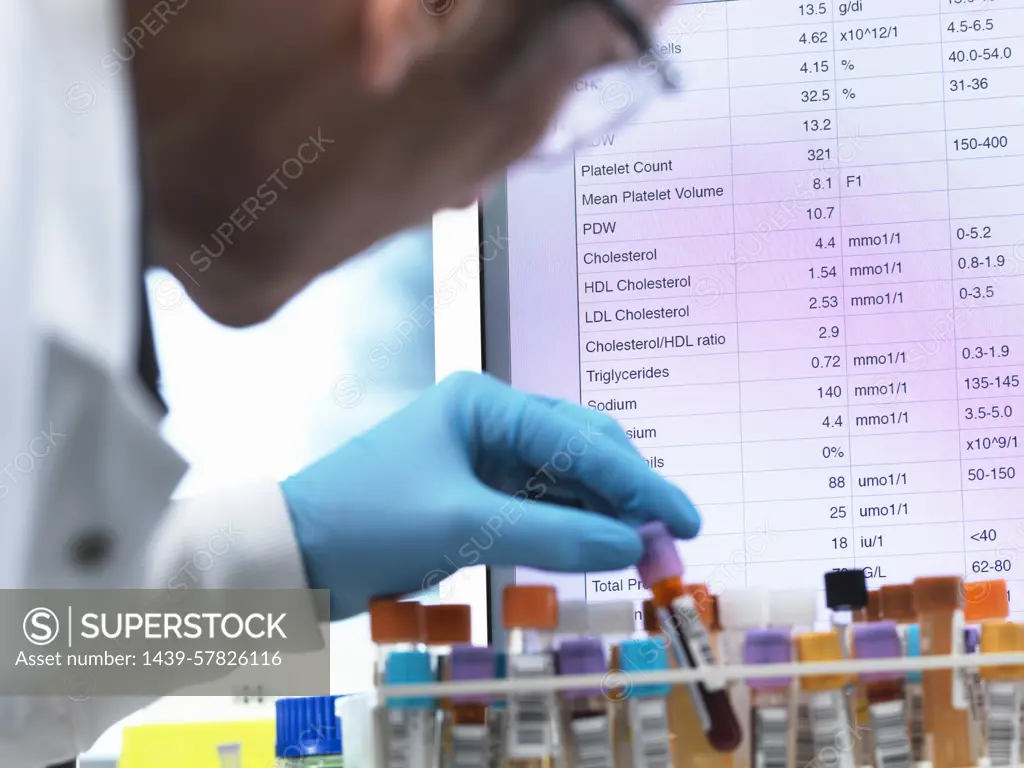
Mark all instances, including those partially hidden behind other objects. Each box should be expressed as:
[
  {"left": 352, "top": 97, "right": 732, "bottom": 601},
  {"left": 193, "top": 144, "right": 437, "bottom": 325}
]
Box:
[{"left": 981, "top": 621, "right": 1024, "bottom": 768}]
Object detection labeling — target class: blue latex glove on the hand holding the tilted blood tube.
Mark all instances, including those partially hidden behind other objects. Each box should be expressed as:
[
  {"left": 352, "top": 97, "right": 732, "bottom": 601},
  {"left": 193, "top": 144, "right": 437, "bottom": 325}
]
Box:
[{"left": 282, "top": 374, "right": 700, "bottom": 620}]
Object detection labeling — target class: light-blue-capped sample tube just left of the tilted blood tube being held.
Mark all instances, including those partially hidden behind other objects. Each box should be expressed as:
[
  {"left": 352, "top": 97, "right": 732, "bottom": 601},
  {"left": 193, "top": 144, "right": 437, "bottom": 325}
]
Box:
[{"left": 616, "top": 637, "right": 674, "bottom": 768}]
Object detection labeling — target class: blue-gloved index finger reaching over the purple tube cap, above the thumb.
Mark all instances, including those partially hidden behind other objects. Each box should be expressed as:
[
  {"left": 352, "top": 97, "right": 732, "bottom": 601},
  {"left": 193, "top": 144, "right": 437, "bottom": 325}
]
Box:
[{"left": 470, "top": 380, "right": 700, "bottom": 539}]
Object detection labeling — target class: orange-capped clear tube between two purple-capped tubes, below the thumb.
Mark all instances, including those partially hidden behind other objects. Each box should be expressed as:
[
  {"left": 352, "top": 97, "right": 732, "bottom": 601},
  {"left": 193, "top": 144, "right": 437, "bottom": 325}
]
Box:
[{"left": 502, "top": 585, "right": 558, "bottom": 768}]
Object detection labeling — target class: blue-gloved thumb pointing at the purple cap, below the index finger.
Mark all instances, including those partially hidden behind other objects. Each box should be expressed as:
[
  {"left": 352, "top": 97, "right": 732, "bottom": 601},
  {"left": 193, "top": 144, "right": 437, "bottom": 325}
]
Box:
[{"left": 469, "top": 485, "right": 643, "bottom": 573}]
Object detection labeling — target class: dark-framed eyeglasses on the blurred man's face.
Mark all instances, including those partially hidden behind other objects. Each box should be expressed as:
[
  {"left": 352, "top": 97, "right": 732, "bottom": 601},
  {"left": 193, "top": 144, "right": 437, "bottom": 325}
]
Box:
[{"left": 531, "top": 0, "right": 683, "bottom": 160}]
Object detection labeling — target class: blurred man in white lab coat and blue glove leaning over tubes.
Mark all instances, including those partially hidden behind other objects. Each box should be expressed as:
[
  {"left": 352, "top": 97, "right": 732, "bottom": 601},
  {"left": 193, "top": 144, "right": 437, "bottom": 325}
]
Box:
[{"left": 0, "top": 0, "right": 698, "bottom": 768}]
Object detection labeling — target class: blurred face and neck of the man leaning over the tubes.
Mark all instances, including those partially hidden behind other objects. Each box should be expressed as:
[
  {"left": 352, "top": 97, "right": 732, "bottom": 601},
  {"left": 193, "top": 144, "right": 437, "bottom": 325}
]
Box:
[{"left": 132, "top": 0, "right": 659, "bottom": 326}]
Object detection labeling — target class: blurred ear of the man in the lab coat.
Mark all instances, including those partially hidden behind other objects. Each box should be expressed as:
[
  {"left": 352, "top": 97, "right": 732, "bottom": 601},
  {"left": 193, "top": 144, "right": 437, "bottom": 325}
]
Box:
[{"left": 362, "top": 0, "right": 480, "bottom": 91}]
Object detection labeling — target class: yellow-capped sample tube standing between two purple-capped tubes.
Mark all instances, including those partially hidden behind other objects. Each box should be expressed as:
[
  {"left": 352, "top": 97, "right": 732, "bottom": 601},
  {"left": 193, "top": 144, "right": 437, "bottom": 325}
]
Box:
[{"left": 796, "top": 630, "right": 856, "bottom": 768}]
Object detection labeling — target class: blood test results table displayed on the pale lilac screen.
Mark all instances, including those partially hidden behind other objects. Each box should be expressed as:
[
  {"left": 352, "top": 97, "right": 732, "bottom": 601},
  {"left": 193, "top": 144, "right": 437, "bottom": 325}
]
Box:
[{"left": 574, "top": 0, "right": 1024, "bottom": 616}]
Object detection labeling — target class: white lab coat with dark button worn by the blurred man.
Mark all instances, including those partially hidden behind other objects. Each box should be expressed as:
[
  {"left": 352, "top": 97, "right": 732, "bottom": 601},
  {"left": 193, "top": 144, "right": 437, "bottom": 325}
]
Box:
[{"left": 0, "top": 0, "right": 305, "bottom": 768}]
